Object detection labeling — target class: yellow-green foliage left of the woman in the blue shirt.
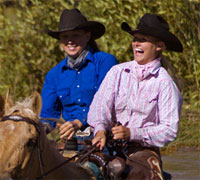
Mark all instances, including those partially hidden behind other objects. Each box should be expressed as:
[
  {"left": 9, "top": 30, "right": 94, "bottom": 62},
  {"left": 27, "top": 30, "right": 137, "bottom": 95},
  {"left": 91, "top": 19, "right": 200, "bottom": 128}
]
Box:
[{"left": 0, "top": 0, "right": 73, "bottom": 97}]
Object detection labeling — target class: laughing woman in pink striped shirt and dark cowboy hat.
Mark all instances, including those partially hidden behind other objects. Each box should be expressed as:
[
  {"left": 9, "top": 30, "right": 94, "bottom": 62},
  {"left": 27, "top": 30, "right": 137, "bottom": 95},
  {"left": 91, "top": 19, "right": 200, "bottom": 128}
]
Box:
[{"left": 88, "top": 13, "right": 183, "bottom": 179}]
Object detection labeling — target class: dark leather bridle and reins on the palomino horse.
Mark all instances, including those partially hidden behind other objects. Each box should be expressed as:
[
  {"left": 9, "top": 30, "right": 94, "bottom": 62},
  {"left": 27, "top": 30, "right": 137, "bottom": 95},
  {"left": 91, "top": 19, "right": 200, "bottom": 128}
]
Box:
[{"left": 0, "top": 115, "right": 98, "bottom": 180}]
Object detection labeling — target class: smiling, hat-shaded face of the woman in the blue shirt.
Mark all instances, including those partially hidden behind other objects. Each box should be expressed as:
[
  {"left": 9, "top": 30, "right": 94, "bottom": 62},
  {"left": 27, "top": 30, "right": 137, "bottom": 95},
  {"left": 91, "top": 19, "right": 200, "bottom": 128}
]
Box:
[{"left": 59, "top": 30, "right": 91, "bottom": 59}]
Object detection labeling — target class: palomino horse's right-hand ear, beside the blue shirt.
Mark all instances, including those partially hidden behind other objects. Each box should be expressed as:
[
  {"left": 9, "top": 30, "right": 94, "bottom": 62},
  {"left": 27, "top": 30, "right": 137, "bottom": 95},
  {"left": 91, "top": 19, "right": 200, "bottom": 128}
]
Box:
[{"left": 32, "top": 91, "right": 42, "bottom": 116}]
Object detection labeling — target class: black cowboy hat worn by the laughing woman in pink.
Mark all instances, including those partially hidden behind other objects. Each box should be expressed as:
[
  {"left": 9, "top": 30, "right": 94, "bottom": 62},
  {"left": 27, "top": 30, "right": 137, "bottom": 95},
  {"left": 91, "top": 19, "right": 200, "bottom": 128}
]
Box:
[{"left": 121, "top": 13, "right": 183, "bottom": 52}]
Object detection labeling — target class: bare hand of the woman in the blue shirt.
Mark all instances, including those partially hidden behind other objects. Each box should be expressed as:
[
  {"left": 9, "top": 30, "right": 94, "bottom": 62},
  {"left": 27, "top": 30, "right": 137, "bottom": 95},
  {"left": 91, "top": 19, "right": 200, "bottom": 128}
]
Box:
[{"left": 57, "top": 119, "right": 83, "bottom": 139}]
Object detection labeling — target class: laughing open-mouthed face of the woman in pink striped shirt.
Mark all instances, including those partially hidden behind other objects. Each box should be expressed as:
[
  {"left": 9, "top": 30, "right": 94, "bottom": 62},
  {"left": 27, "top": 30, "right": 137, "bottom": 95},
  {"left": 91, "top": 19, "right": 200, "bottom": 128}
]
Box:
[{"left": 132, "top": 33, "right": 165, "bottom": 65}]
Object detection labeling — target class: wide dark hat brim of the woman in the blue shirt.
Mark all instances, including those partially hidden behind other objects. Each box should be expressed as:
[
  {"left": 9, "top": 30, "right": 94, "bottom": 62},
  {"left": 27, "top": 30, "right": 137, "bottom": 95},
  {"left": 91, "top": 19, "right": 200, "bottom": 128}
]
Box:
[{"left": 46, "top": 21, "right": 105, "bottom": 40}]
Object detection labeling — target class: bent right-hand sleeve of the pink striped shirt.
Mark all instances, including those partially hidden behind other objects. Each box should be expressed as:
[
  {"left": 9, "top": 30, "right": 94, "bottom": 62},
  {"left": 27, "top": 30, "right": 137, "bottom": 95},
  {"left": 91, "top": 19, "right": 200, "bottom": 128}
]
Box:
[{"left": 130, "top": 79, "right": 183, "bottom": 147}]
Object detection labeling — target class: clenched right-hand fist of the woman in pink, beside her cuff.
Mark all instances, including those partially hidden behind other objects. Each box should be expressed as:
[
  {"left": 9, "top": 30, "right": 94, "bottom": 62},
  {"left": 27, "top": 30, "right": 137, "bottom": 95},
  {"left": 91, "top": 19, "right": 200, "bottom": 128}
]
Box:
[{"left": 111, "top": 125, "right": 130, "bottom": 140}]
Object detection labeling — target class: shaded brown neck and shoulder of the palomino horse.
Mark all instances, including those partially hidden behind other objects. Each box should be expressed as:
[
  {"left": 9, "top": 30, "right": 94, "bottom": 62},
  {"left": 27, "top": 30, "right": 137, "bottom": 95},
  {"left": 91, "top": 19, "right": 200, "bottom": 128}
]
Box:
[{"left": 25, "top": 124, "right": 91, "bottom": 179}]
